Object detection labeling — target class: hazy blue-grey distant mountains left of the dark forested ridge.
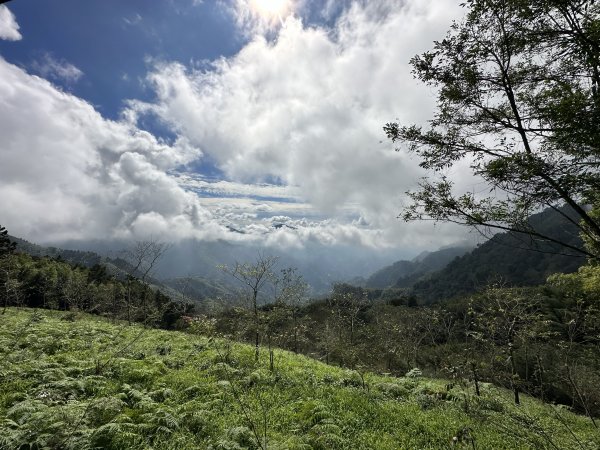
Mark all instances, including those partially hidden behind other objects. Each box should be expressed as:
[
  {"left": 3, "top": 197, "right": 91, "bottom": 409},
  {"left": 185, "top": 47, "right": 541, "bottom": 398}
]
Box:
[{"left": 5, "top": 237, "right": 404, "bottom": 302}]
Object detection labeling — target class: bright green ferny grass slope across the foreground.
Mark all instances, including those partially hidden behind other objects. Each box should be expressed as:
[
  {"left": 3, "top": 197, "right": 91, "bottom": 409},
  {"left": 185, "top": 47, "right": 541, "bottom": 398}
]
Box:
[{"left": 0, "top": 309, "right": 600, "bottom": 450}]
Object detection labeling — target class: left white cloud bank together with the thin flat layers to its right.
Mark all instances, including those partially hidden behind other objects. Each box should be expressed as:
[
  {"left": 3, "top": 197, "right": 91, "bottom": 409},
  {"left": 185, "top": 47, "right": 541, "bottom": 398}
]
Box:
[{"left": 0, "top": 58, "right": 404, "bottom": 247}]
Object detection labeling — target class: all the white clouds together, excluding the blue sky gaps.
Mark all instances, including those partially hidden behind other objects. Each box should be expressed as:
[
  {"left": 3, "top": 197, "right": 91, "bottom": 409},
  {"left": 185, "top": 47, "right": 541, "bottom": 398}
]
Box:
[{"left": 0, "top": 0, "right": 462, "bottom": 249}]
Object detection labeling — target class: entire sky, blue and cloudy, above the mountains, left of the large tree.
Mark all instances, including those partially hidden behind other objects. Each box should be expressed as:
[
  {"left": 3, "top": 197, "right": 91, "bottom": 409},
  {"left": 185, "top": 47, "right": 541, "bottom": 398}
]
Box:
[{"left": 0, "top": 0, "right": 475, "bottom": 252}]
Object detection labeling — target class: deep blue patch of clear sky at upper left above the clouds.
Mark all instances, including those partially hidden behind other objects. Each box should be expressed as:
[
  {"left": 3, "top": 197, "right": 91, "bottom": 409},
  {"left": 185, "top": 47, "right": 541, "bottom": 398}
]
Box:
[{"left": 0, "top": 0, "right": 243, "bottom": 118}]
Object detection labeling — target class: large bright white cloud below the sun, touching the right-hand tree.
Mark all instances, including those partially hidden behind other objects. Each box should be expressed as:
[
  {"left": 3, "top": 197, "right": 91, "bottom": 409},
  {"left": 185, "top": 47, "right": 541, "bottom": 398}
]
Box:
[{"left": 129, "top": 0, "right": 462, "bottom": 244}]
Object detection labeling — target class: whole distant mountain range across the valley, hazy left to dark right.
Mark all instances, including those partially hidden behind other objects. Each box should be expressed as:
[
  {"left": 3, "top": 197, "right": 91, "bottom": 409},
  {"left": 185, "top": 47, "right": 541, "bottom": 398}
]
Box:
[{"left": 11, "top": 205, "right": 585, "bottom": 303}]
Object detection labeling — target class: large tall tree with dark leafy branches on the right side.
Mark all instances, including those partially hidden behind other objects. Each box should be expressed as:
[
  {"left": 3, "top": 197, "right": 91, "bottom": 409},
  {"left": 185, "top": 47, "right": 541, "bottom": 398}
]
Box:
[{"left": 384, "top": 0, "right": 600, "bottom": 260}]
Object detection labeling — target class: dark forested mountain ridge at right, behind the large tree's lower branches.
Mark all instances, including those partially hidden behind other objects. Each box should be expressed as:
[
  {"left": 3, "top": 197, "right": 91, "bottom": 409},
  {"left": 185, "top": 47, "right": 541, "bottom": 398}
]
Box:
[{"left": 366, "top": 209, "right": 586, "bottom": 303}]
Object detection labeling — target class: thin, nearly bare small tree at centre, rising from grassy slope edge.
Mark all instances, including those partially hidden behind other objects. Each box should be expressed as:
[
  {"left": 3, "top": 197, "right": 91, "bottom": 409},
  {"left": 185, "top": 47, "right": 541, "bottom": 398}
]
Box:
[{"left": 220, "top": 253, "right": 278, "bottom": 361}]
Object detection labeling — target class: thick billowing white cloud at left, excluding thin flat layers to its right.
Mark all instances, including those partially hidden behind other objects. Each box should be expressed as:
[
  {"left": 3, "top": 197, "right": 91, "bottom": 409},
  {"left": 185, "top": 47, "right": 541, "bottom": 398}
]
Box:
[{"left": 0, "top": 58, "right": 222, "bottom": 241}]
